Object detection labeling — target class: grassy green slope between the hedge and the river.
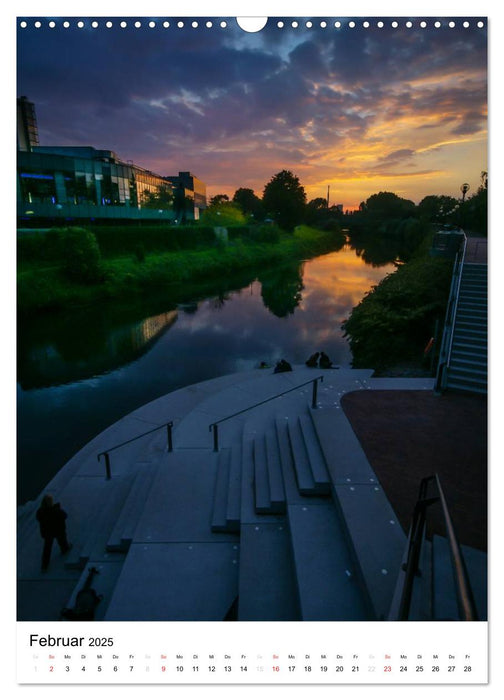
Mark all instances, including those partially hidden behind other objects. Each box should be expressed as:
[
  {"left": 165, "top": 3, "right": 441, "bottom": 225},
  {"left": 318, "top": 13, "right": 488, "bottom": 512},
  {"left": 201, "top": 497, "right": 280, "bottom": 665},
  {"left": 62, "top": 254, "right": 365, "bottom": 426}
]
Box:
[{"left": 18, "top": 226, "right": 344, "bottom": 315}]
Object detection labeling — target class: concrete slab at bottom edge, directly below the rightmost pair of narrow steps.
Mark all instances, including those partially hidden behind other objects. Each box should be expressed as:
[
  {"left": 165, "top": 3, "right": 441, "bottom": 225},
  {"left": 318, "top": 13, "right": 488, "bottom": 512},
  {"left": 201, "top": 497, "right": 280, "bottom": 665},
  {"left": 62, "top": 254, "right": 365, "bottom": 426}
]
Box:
[{"left": 287, "top": 499, "right": 370, "bottom": 621}]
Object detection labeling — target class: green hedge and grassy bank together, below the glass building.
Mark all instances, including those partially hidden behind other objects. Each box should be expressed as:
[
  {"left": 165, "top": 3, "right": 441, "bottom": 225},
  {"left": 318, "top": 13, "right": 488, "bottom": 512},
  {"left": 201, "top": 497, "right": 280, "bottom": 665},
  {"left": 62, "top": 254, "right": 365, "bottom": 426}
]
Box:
[{"left": 18, "top": 224, "right": 345, "bottom": 314}]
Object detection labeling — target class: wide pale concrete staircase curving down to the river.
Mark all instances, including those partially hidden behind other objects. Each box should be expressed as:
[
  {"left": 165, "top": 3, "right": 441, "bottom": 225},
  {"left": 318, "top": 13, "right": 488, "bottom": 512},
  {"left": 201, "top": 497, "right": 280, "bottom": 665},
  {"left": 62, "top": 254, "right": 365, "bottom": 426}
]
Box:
[{"left": 18, "top": 371, "right": 486, "bottom": 621}]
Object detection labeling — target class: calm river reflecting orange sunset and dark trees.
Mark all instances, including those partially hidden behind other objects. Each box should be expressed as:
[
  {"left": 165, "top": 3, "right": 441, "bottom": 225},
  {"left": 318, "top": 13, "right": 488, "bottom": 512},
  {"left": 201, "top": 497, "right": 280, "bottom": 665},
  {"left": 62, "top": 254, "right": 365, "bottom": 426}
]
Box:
[{"left": 18, "top": 247, "right": 394, "bottom": 503}]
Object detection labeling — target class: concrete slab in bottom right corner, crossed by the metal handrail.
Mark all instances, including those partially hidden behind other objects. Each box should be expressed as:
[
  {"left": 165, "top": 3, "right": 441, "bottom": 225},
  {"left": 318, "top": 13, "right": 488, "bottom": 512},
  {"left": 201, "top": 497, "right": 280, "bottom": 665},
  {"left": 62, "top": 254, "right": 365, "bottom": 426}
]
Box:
[{"left": 432, "top": 535, "right": 487, "bottom": 620}]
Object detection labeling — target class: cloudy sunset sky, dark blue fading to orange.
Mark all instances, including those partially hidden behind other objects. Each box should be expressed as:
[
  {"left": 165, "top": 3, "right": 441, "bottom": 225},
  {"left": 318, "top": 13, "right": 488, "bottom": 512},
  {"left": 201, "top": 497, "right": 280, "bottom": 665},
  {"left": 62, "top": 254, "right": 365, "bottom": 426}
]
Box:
[{"left": 17, "top": 17, "right": 487, "bottom": 209}]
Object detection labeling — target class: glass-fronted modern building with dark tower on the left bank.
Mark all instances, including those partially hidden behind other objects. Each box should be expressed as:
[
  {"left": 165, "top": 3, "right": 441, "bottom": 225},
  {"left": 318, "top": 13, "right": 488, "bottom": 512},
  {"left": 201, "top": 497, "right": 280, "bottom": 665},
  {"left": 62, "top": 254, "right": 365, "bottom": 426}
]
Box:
[{"left": 17, "top": 97, "right": 206, "bottom": 227}]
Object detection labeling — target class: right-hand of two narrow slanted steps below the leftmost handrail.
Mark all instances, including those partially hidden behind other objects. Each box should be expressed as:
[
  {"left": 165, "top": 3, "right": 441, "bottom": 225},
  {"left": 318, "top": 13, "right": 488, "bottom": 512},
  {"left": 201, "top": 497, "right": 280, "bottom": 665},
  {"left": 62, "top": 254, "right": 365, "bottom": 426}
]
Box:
[{"left": 106, "top": 461, "right": 162, "bottom": 552}]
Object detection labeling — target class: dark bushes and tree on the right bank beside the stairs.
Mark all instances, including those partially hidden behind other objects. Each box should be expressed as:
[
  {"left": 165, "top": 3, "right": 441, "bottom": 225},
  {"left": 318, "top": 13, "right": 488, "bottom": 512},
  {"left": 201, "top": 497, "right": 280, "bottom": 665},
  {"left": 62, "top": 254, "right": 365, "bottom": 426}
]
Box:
[{"left": 342, "top": 193, "right": 453, "bottom": 374}]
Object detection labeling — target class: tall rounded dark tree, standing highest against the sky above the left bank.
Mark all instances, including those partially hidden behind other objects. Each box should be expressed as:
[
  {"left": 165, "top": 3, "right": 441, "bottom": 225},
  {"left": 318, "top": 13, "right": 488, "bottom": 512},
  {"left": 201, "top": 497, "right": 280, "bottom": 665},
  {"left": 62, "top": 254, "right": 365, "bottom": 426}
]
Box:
[{"left": 263, "top": 170, "right": 306, "bottom": 231}]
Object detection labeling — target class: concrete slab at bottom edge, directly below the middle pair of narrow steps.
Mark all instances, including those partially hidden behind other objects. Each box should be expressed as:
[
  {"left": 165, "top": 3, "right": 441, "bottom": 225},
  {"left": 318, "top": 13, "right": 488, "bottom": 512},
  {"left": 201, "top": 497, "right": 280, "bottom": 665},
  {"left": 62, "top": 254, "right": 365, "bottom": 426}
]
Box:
[{"left": 238, "top": 516, "right": 300, "bottom": 621}]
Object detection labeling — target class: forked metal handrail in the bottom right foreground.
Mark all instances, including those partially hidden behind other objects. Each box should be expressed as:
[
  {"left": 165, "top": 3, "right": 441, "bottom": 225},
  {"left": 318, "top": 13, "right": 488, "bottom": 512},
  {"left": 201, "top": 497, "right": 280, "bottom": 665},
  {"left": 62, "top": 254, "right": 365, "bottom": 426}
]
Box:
[{"left": 389, "top": 474, "right": 478, "bottom": 621}]
